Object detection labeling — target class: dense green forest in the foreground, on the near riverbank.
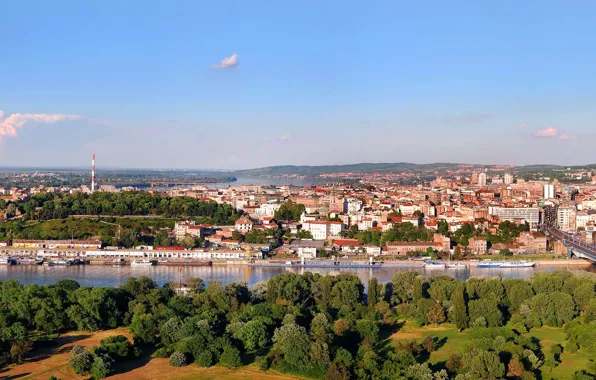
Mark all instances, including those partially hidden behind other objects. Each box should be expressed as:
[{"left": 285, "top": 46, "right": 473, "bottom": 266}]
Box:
[{"left": 0, "top": 271, "right": 596, "bottom": 380}]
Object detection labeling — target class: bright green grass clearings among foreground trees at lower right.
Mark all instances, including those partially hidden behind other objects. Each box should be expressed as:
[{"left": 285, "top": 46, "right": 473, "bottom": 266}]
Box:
[{"left": 390, "top": 321, "right": 596, "bottom": 380}]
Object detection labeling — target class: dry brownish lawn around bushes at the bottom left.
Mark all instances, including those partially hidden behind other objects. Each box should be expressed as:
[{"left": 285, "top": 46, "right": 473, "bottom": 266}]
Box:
[{"left": 0, "top": 329, "right": 296, "bottom": 380}]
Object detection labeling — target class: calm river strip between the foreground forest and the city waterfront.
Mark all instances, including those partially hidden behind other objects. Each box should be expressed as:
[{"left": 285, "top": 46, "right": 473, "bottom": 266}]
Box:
[{"left": 0, "top": 265, "right": 596, "bottom": 286}]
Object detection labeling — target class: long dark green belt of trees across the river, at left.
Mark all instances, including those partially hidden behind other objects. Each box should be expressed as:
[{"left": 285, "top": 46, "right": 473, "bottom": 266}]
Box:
[{"left": 0, "top": 191, "right": 239, "bottom": 225}]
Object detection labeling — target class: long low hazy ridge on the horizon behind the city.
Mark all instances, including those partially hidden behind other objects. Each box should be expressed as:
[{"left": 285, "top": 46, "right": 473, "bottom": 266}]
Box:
[{"left": 233, "top": 162, "right": 596, "bottom": 177}]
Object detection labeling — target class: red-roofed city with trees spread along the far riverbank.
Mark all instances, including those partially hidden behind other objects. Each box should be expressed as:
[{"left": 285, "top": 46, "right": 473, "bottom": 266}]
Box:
[{"left": 0, "top": 160, "right": 596, "bottom": 264}]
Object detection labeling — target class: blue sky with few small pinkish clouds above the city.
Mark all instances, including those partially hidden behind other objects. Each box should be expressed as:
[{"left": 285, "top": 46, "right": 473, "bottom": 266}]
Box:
[{"left": 0, "top": 0, "right": 596, "bottom": 168}]
